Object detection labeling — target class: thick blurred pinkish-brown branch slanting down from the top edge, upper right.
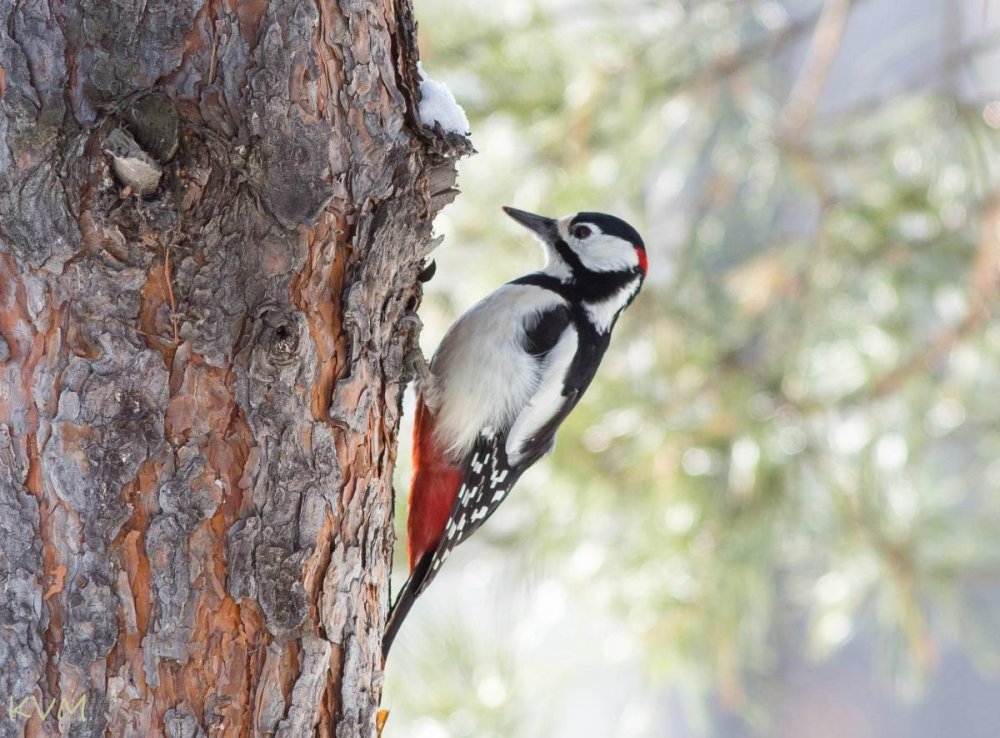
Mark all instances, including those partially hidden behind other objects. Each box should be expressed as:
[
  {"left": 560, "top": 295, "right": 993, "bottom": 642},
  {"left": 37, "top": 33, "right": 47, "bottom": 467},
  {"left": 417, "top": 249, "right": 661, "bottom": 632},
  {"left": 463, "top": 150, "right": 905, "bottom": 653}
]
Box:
[{"left": 778, "top": 0, "right": 853, "bottom": 144}]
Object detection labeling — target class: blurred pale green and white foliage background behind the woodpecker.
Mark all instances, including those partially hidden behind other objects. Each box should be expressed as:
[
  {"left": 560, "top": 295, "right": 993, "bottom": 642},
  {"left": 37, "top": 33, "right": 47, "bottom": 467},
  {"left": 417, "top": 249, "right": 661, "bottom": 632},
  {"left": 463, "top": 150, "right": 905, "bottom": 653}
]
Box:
[{"left": 383, "top": 0, "right": 1000, "bottom": 738}]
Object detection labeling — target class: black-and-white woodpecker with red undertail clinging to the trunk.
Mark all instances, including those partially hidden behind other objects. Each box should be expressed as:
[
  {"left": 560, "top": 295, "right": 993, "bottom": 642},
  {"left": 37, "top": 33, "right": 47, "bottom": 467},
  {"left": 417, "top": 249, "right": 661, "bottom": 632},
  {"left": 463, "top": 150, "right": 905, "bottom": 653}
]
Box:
[{"left": 382, "top": 207, "right": 647, "bottom": 656}]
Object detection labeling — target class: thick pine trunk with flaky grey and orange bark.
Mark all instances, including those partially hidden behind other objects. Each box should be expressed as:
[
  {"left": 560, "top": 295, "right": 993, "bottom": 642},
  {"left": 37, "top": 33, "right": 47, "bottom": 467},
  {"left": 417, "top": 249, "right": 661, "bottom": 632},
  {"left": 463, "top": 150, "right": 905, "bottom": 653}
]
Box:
[{"left": 0, "top": 0, "right": 468, "bottom": 738}]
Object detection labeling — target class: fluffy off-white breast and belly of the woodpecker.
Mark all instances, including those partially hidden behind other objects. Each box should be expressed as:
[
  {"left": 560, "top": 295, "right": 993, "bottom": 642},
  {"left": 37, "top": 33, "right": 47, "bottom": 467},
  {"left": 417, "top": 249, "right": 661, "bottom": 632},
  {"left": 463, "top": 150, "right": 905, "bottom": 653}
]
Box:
[{"left": 424, "top": 284, "right": 566, "bottom": 460}]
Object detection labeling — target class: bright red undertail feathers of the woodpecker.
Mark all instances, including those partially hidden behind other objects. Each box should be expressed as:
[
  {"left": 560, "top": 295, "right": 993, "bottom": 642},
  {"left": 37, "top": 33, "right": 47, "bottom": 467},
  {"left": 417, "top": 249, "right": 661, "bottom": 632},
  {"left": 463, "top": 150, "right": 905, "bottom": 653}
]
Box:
[{"left": 406, "top": 397, "right": 462, "bottom": 572}]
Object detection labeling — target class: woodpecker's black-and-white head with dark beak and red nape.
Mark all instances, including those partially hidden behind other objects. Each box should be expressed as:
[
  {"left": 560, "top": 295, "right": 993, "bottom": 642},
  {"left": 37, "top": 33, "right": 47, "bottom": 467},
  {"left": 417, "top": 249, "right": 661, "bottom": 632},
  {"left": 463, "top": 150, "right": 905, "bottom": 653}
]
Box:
[{"left": 504, "top": 207, "right": 647, "bottom": 281}]
